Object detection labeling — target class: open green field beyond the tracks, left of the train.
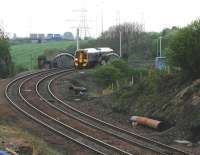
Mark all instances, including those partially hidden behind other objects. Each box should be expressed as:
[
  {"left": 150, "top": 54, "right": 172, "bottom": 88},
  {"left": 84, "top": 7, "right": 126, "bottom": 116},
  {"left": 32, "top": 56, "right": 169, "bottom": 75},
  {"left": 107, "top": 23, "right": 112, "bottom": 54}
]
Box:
[{"left": 11, "top": 41, "right": 76, "bottom": 70}]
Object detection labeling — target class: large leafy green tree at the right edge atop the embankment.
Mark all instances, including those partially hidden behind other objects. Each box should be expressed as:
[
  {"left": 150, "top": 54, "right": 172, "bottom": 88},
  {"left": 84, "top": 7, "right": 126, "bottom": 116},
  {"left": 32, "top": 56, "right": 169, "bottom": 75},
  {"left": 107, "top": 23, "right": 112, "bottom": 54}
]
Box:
[{"left": 168, "top": 19, "right": 200, "bottom": 79}]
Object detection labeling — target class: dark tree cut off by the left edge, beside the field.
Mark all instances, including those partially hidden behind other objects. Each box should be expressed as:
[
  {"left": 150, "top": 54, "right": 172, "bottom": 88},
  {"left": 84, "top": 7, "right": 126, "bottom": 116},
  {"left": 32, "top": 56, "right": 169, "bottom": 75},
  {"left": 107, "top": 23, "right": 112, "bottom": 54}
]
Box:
[{"left": 0, "top": 29, "right": 12, "bottom": 78}]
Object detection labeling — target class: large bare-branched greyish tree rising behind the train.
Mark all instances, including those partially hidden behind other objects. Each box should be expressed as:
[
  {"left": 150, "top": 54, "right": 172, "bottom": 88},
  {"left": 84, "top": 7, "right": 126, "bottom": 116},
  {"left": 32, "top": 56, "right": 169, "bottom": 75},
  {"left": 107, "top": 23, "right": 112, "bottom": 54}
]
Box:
[{"left": 97, "top": 23, "right": 144, "bottom": 58}]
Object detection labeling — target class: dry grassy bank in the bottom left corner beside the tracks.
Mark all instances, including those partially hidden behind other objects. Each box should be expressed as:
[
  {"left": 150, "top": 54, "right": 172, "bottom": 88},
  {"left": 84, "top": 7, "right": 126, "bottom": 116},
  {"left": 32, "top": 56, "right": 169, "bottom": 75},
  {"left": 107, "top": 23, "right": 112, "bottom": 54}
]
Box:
[{"left": 0, "top": 124, "right": 61, "bottom": 155}]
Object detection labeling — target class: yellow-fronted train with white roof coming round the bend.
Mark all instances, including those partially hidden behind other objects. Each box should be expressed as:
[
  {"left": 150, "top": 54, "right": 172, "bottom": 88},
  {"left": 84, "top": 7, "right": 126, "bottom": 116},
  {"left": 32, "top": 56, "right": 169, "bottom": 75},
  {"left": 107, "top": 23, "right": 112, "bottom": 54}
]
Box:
[{"left": 74, "top": 47, "right": 119, "bottom": 69}]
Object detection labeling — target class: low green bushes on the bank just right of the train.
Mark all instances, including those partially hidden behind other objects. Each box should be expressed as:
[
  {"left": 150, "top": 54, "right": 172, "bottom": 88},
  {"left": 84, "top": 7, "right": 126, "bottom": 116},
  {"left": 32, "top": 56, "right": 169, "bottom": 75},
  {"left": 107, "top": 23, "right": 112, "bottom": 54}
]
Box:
[{"left": 94, "top": 60, "right": 165, "bottom": 92}]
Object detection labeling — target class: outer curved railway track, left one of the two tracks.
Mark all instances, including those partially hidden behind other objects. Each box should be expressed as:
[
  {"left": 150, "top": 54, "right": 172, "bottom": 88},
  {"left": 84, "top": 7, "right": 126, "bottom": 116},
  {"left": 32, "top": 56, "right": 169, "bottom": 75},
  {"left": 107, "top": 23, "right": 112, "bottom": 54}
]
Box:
[{"left": 5, "top": 71, "right": 105, "bottom": 155}]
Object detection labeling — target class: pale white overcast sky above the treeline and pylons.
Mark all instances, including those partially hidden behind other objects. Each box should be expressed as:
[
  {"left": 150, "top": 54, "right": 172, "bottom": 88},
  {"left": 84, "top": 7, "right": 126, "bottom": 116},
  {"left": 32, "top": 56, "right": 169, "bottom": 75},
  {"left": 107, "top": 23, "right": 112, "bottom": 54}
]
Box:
[{"left": 0, "top": 0, "right": 200, "bottom": 37}]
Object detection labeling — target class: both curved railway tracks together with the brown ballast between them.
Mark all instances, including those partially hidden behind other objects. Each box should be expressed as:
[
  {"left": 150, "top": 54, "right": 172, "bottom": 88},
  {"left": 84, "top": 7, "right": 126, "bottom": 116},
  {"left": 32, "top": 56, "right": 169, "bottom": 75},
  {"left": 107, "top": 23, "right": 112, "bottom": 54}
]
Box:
[{"left": 5, "top": 70, "right": 194, "bottom": 155}]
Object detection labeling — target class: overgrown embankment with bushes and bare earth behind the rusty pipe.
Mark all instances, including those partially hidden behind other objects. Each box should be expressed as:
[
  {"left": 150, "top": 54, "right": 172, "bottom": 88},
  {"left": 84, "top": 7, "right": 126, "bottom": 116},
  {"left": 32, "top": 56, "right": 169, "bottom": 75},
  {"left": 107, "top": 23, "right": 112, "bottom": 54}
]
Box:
[{"left": 92, "top": 61, "right": 200, "bottom": 141}]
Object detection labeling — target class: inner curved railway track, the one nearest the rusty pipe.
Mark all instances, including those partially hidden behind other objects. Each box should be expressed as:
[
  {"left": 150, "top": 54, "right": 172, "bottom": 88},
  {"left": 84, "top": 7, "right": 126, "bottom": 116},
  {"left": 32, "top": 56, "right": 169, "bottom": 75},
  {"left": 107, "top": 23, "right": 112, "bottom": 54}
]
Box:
[{"left": 45, "top": 71, "right": 192, "bottom": 155}]
